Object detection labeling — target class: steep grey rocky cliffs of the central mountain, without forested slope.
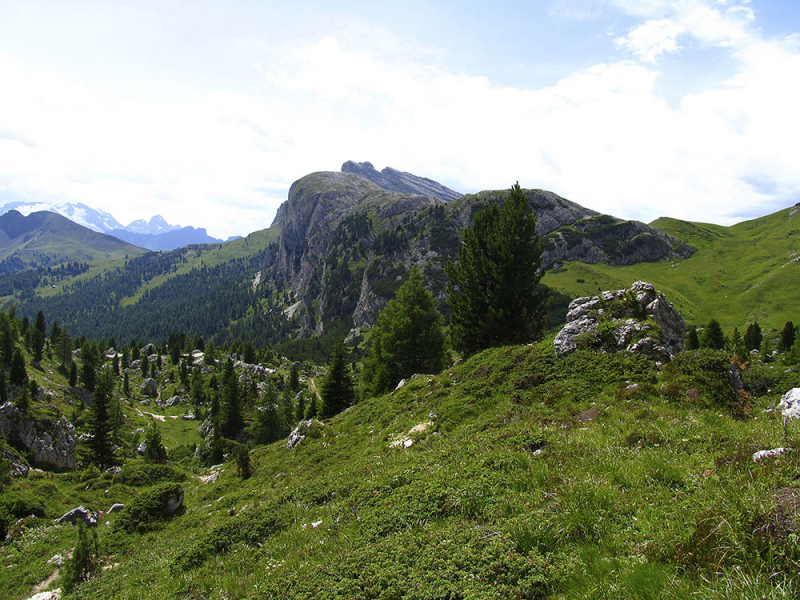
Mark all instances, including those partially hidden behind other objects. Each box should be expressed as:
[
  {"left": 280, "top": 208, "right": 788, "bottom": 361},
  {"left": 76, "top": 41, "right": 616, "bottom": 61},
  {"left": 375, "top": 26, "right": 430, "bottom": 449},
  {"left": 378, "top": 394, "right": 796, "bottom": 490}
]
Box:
[{"left": 262, "top": 168, "right": 693, "bottom": 337}]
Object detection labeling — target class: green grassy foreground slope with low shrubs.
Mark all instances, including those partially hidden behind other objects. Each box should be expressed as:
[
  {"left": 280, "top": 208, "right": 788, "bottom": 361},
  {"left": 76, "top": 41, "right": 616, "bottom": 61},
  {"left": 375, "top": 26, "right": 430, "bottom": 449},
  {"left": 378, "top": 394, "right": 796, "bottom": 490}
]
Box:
[{"left": 0, "top": 340, "right": 800, "bottom": 599}]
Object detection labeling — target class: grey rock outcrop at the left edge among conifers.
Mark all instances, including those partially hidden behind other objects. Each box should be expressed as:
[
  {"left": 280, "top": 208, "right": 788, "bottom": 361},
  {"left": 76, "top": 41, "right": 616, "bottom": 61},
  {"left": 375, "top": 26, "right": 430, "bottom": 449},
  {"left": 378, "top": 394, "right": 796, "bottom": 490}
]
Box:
[{"left": 0, "top": 402, "right": 78, "bottom": 471}]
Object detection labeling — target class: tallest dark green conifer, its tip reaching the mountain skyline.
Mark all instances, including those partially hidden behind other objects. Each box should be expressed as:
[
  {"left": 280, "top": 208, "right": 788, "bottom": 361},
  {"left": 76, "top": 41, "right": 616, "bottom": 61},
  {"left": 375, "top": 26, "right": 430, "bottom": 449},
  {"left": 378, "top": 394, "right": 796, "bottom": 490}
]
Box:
[{"left": 446, "top": 184, "right": 546, "bottom": 355}]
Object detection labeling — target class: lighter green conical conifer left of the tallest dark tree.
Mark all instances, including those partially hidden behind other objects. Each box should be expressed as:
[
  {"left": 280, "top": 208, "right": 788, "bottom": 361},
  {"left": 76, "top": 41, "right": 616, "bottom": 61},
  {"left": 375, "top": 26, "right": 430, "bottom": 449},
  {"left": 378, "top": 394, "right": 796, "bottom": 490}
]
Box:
[{"left": 361, "top": 266, "right": 446, "bottom": 396}]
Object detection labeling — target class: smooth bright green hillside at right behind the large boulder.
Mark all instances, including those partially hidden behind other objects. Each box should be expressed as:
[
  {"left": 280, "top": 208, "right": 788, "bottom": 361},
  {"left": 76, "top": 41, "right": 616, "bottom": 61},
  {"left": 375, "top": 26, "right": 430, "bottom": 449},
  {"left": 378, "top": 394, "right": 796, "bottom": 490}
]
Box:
[{"left": 544, "top": 206, "right": 800, "bottom": 332}]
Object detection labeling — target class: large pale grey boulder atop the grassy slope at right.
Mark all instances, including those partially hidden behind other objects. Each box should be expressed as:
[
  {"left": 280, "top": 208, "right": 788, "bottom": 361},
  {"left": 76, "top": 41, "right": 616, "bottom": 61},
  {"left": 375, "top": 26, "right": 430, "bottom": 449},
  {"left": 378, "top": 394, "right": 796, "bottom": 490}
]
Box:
[{"left": 553, "top": 281, "right": 686, "bottom": 362}]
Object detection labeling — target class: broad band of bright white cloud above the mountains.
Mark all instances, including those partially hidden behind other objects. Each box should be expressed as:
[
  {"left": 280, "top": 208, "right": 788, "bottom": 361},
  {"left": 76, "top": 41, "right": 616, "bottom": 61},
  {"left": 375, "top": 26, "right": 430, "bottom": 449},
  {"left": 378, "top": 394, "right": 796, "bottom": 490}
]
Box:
[{"left": 0, "top": 0, "right": 800, "bottom": 237}]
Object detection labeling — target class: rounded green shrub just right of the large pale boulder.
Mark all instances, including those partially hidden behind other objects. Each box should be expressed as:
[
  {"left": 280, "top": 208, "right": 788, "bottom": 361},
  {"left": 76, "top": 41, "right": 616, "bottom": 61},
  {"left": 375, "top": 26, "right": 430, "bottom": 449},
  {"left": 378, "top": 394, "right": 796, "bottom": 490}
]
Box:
[{"left": 662, "top": 348, "right": 738, "bottom": 407}]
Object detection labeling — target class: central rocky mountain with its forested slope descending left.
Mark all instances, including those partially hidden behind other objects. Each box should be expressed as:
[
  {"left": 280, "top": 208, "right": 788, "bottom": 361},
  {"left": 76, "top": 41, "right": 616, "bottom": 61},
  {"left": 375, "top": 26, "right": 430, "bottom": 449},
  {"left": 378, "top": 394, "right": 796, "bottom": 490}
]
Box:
[{"left": 3, "top": 172, "right": 693, "bottom": 346}]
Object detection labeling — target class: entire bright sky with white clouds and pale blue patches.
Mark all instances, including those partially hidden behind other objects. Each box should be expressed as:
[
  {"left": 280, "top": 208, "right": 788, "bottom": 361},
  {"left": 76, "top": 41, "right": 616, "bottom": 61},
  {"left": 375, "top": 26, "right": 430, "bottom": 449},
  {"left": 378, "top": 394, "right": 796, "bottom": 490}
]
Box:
[{"left": 0, "top": 0, "right": 800, "bottom": 238}]
